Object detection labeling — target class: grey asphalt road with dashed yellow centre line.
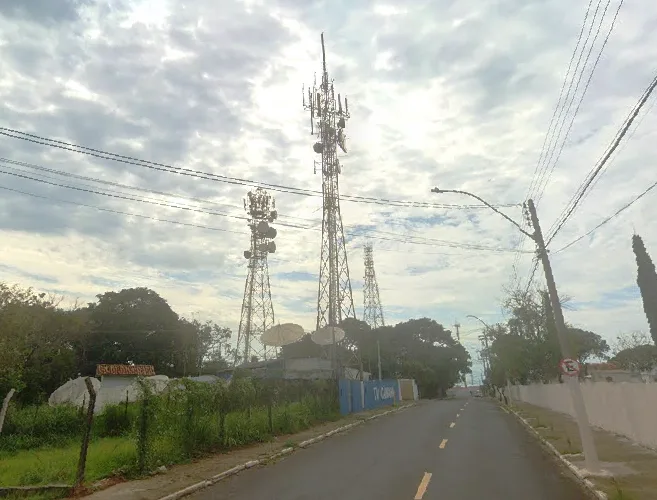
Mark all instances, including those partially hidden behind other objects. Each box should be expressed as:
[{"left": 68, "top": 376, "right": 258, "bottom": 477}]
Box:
[{"left": 190, "top": 398, "right": 587, "bottom": 500}]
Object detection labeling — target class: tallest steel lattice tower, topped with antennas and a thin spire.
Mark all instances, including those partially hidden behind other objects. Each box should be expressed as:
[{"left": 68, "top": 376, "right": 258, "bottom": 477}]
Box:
[{"left": 303, "top": 33, "right": 356, "bottom": 330}]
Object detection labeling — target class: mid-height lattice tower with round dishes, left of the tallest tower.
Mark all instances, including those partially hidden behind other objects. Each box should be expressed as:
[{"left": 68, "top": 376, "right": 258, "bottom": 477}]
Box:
[{"left": 234, "top": 188, "right": 278, "bottom": 365}]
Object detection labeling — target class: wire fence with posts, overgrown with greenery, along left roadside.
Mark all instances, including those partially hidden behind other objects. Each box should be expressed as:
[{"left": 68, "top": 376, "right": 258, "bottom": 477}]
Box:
[{"left": 0, "top": 376, "right": 340, "bottom": 490}]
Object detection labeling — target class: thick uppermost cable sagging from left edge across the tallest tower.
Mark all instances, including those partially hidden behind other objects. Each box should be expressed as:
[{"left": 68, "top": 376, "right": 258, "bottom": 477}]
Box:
[{"left": 0, "top": 127, "right": 518, "bottom": 209}]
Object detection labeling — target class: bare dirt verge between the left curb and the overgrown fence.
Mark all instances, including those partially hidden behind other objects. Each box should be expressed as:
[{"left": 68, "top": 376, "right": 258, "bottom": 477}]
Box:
[{"left": 79, "top": 407, "right": 412, "bottom": 500}]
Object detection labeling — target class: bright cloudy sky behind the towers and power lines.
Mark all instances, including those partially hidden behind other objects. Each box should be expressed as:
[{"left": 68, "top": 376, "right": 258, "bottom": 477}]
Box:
[{"left": 0, "top": 0, "right": 657, "bottom": 381}]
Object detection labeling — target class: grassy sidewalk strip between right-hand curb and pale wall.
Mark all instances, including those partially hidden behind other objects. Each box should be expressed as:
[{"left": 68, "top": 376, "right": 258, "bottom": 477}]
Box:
[{"left": 511, "top": 402, "right": 657, "bottom": 500}]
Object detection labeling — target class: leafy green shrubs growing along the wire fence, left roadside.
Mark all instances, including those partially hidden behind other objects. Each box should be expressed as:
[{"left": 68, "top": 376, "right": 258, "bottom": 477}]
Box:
[{"left": 0, "top": 375, "right": 339, "bottom": 476}]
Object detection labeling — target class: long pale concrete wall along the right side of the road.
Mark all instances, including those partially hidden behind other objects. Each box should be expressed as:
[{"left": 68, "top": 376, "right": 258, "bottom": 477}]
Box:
[{"left": 510, "top": 382, "right": 657, "bottom": 448}]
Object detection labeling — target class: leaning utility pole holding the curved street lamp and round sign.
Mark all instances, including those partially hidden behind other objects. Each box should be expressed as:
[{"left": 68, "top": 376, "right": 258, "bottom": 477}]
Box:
[{"left": 527, "top": 200, "right": 600, "bottom": 472}]
